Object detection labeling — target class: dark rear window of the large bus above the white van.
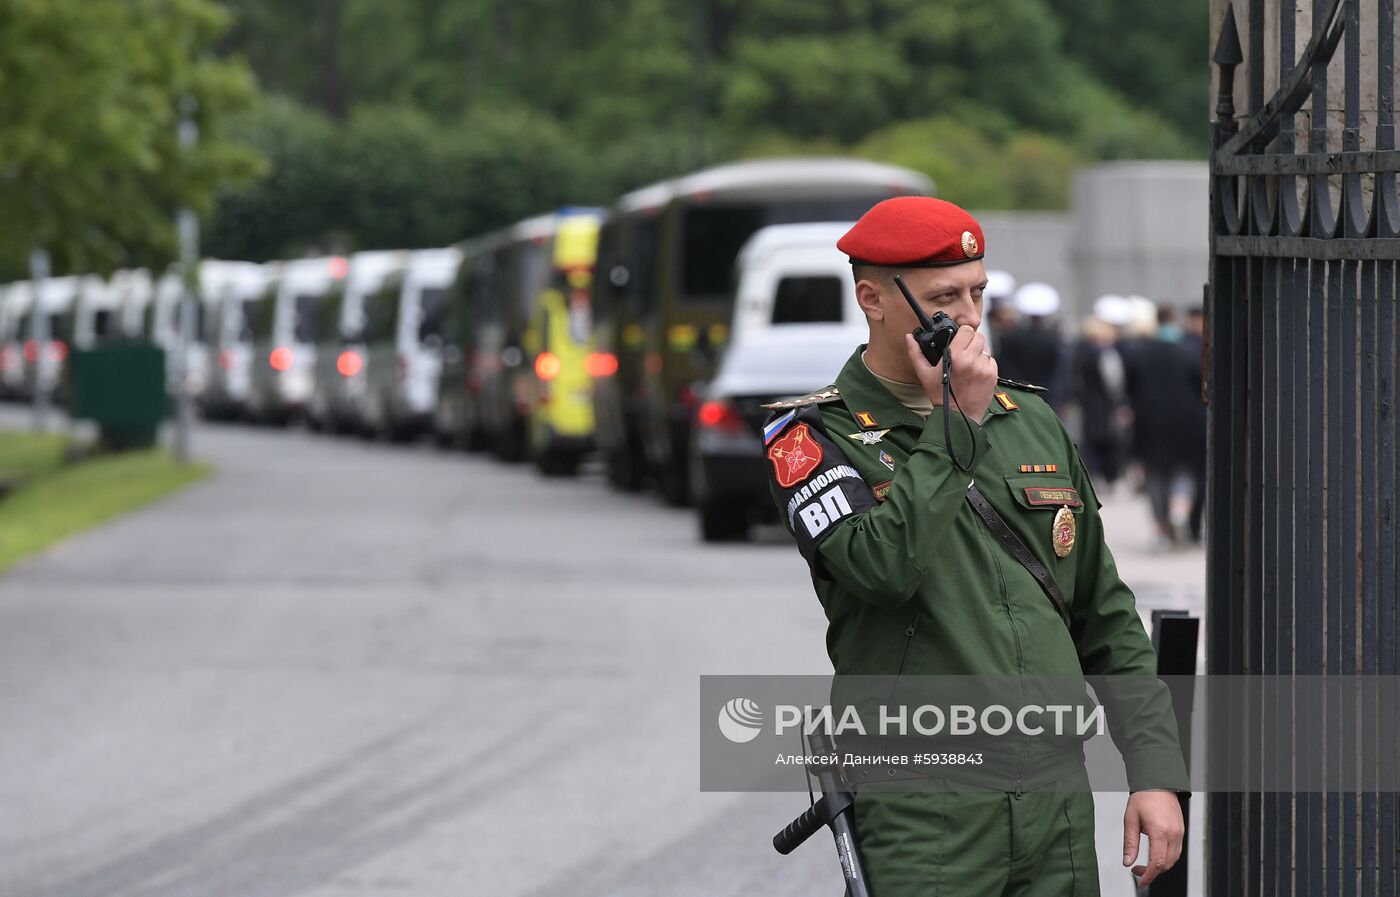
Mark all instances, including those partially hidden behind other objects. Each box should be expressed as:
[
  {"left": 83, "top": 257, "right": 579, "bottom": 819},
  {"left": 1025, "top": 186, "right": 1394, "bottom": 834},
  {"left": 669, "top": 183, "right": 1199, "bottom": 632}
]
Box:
[{"left": 679, "top": 196, "right": 885, "bottom": 302}]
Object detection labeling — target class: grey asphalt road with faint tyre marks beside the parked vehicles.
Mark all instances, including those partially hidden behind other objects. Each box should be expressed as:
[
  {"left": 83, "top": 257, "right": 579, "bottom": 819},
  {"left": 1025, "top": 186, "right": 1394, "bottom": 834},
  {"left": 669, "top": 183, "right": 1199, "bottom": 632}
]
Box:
[{"left": 0, "top": 411, "right": 1204, "bottom": 897}]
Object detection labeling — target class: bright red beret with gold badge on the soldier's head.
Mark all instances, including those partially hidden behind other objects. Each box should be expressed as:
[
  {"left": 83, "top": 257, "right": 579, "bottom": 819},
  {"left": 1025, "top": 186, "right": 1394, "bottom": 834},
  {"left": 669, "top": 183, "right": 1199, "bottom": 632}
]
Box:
[{"left": 836, "top": 196, "right": 987, "bottom": 267}]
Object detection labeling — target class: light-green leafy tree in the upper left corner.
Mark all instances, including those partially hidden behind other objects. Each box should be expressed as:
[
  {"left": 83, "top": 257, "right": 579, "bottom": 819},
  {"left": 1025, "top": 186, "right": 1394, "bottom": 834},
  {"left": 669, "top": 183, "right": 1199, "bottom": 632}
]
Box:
[{"left": 0, "top": 0, "right": 258, "bottom": 274}]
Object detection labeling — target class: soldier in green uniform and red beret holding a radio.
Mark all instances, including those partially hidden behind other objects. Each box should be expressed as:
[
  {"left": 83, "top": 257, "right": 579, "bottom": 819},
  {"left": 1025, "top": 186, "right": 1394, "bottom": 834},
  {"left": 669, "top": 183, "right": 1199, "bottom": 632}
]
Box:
[{"left": 764, "top": 197, "right": 1190, "bottom": 897}]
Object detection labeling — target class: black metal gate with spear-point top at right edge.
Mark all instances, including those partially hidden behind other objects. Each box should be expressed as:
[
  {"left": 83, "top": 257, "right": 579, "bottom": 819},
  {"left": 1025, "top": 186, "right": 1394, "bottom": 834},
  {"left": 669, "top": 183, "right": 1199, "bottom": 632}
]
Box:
[{"left": 1205, "top": 0, "right": 1400, "bottom": 897}]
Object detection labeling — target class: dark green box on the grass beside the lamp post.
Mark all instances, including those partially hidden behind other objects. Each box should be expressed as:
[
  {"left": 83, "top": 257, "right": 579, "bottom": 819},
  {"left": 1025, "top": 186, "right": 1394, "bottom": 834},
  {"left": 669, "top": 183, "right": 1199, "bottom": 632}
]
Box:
[{"left": 69, "top": 343, "right": 171, "bottom": 449}]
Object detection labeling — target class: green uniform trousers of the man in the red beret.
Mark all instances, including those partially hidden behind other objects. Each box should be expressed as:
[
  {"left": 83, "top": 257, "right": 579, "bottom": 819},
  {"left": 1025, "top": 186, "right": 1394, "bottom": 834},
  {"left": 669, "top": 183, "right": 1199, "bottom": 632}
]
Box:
[{"left": 855, "top": 779, "right": 1099, "bottom": 897}]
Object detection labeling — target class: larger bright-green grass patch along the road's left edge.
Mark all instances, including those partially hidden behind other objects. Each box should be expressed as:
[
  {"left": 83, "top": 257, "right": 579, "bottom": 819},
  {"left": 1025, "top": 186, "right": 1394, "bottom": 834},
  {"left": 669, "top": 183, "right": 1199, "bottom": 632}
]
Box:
[{"left": 0, "top": 445, "right": 210, "bottom": 571}]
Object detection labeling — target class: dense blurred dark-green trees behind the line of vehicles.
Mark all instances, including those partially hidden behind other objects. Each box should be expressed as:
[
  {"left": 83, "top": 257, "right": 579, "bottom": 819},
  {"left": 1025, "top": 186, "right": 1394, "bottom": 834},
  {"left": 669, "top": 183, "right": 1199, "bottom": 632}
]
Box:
[{"left": 203, "top": 0, "right": 1204, "bottom": 251}]
